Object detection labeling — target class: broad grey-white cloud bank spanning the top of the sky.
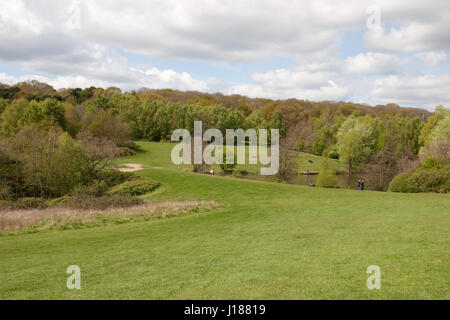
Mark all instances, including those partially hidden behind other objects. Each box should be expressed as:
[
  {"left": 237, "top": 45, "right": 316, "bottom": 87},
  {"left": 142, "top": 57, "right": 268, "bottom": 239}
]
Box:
[{"left": 0, "top": 0, "right": 450, "bottom": 62}]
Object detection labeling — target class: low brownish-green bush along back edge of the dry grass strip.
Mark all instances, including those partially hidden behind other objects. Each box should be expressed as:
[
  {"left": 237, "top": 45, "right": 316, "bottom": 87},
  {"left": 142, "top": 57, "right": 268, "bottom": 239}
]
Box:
[{"left": 63, "top": 195, "right": 143, "bottom": 210}]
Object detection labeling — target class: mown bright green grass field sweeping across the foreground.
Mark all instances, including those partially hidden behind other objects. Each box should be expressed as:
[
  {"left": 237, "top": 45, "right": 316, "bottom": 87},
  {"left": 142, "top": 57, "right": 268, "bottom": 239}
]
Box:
[{"left": 0, "top": 143, "right": 450, "bottom": 299}]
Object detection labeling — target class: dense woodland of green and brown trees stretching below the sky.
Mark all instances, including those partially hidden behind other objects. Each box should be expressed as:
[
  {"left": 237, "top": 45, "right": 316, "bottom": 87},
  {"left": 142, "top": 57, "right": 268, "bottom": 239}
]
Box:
[{"left": 0, "top": 81, "right": 450, "bottom": 205}]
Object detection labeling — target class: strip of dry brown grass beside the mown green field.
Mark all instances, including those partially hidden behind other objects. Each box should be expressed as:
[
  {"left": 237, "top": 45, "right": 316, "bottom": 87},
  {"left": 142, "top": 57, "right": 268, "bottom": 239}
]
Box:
[{"left": 0, "top": 201, "right": 217, "bottom": 231}]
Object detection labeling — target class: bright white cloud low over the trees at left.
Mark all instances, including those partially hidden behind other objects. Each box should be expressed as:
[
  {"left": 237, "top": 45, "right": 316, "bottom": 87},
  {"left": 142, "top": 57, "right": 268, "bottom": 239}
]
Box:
[{"left": 0, "top": 45, "right": 211, "bottom": 91}]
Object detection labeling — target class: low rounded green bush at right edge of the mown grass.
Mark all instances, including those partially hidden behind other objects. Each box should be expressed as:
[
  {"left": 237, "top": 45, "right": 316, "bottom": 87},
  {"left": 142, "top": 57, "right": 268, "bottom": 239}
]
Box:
[{"left": 389, "top": 166, "right": 450, "bottom": 193}]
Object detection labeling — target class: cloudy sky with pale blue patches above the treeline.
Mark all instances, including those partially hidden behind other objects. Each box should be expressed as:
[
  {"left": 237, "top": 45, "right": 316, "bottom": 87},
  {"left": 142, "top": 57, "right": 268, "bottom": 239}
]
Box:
[{"left": 0, "top": 0, "right": 450, "bottom": 110}]
